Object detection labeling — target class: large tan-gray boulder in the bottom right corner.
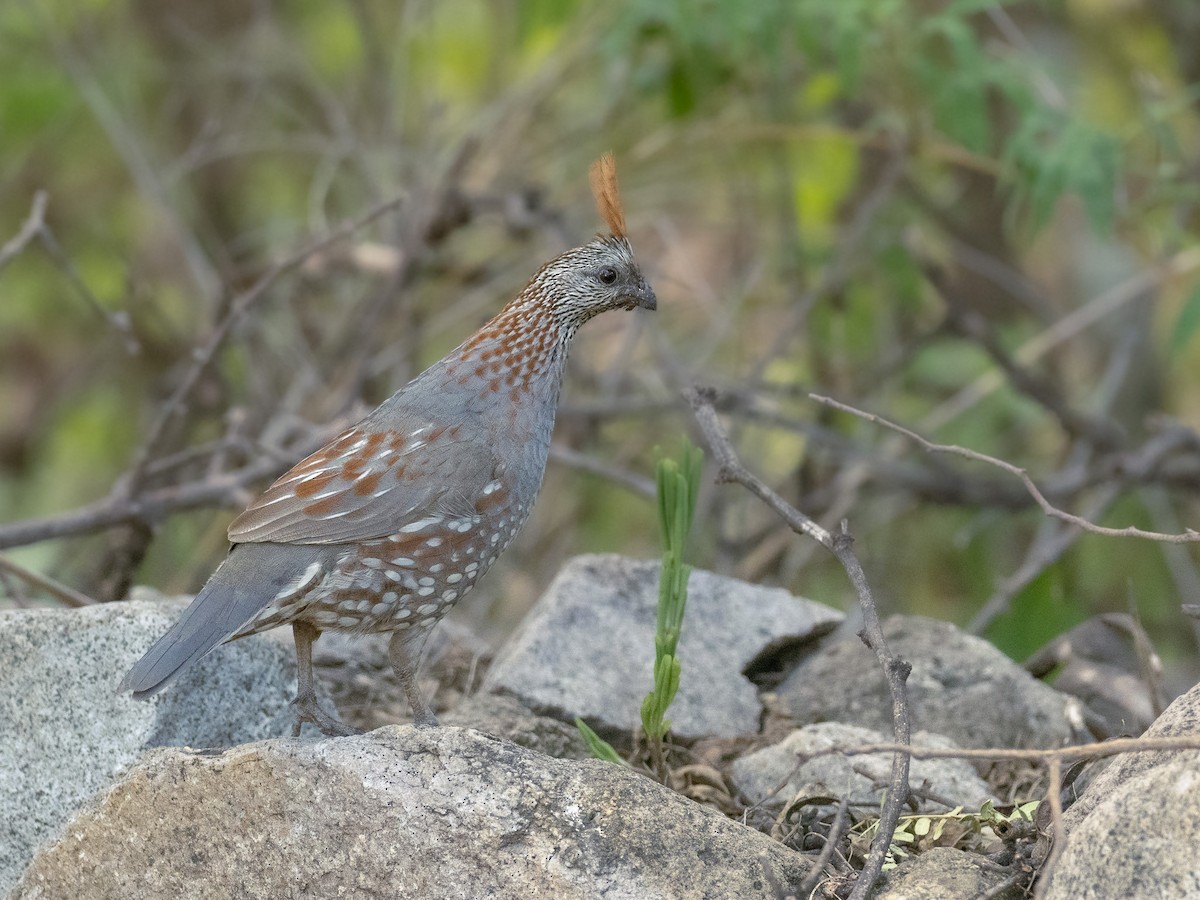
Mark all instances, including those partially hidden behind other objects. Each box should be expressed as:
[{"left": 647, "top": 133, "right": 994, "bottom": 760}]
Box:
[{"left": 1045, "top": 752, "right": 1200, "bottom": 900}]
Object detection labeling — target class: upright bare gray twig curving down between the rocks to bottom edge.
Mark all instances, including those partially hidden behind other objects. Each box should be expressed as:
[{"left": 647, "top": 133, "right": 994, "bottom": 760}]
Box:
[{"left": 685, "top": 388, "right": 912, "bottom": 900}]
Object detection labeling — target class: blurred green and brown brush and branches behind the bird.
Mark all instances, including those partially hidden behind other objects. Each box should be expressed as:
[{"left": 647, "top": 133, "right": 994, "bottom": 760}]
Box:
[{"left": 0, "top": 0, "right": 1200, "bottom": 684}]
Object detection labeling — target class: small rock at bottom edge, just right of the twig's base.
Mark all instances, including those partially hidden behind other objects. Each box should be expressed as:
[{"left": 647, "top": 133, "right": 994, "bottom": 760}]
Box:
[{"left": 872, "top": 847, "right": 1025, "bottom": 900}]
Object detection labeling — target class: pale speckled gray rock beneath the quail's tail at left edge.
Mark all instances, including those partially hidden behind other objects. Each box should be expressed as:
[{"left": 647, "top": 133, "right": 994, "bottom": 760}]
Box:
[{"left": 0, "top": 592, "right": 304, "bottom": 894}]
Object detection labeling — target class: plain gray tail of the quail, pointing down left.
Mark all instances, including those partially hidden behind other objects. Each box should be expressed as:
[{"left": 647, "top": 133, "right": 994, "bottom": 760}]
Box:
[{"left": 116, "top": 544, "right": 324, "bottom": 700}]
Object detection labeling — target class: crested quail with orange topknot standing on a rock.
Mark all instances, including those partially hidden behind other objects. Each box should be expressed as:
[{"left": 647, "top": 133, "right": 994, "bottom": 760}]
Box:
[{"left": 118, "top": 154, "right": 658, "bottom": 736}]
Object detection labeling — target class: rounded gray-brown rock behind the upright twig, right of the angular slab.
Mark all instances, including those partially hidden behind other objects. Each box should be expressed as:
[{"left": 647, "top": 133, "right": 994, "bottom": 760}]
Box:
[{"left": 776, "top": 616, "right": 1082, "bottom": 748}]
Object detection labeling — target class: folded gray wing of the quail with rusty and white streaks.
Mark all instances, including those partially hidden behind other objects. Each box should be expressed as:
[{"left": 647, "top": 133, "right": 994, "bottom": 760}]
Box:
[{"left": 229, "top": 419, "right": 503, "bottom": 544}]
